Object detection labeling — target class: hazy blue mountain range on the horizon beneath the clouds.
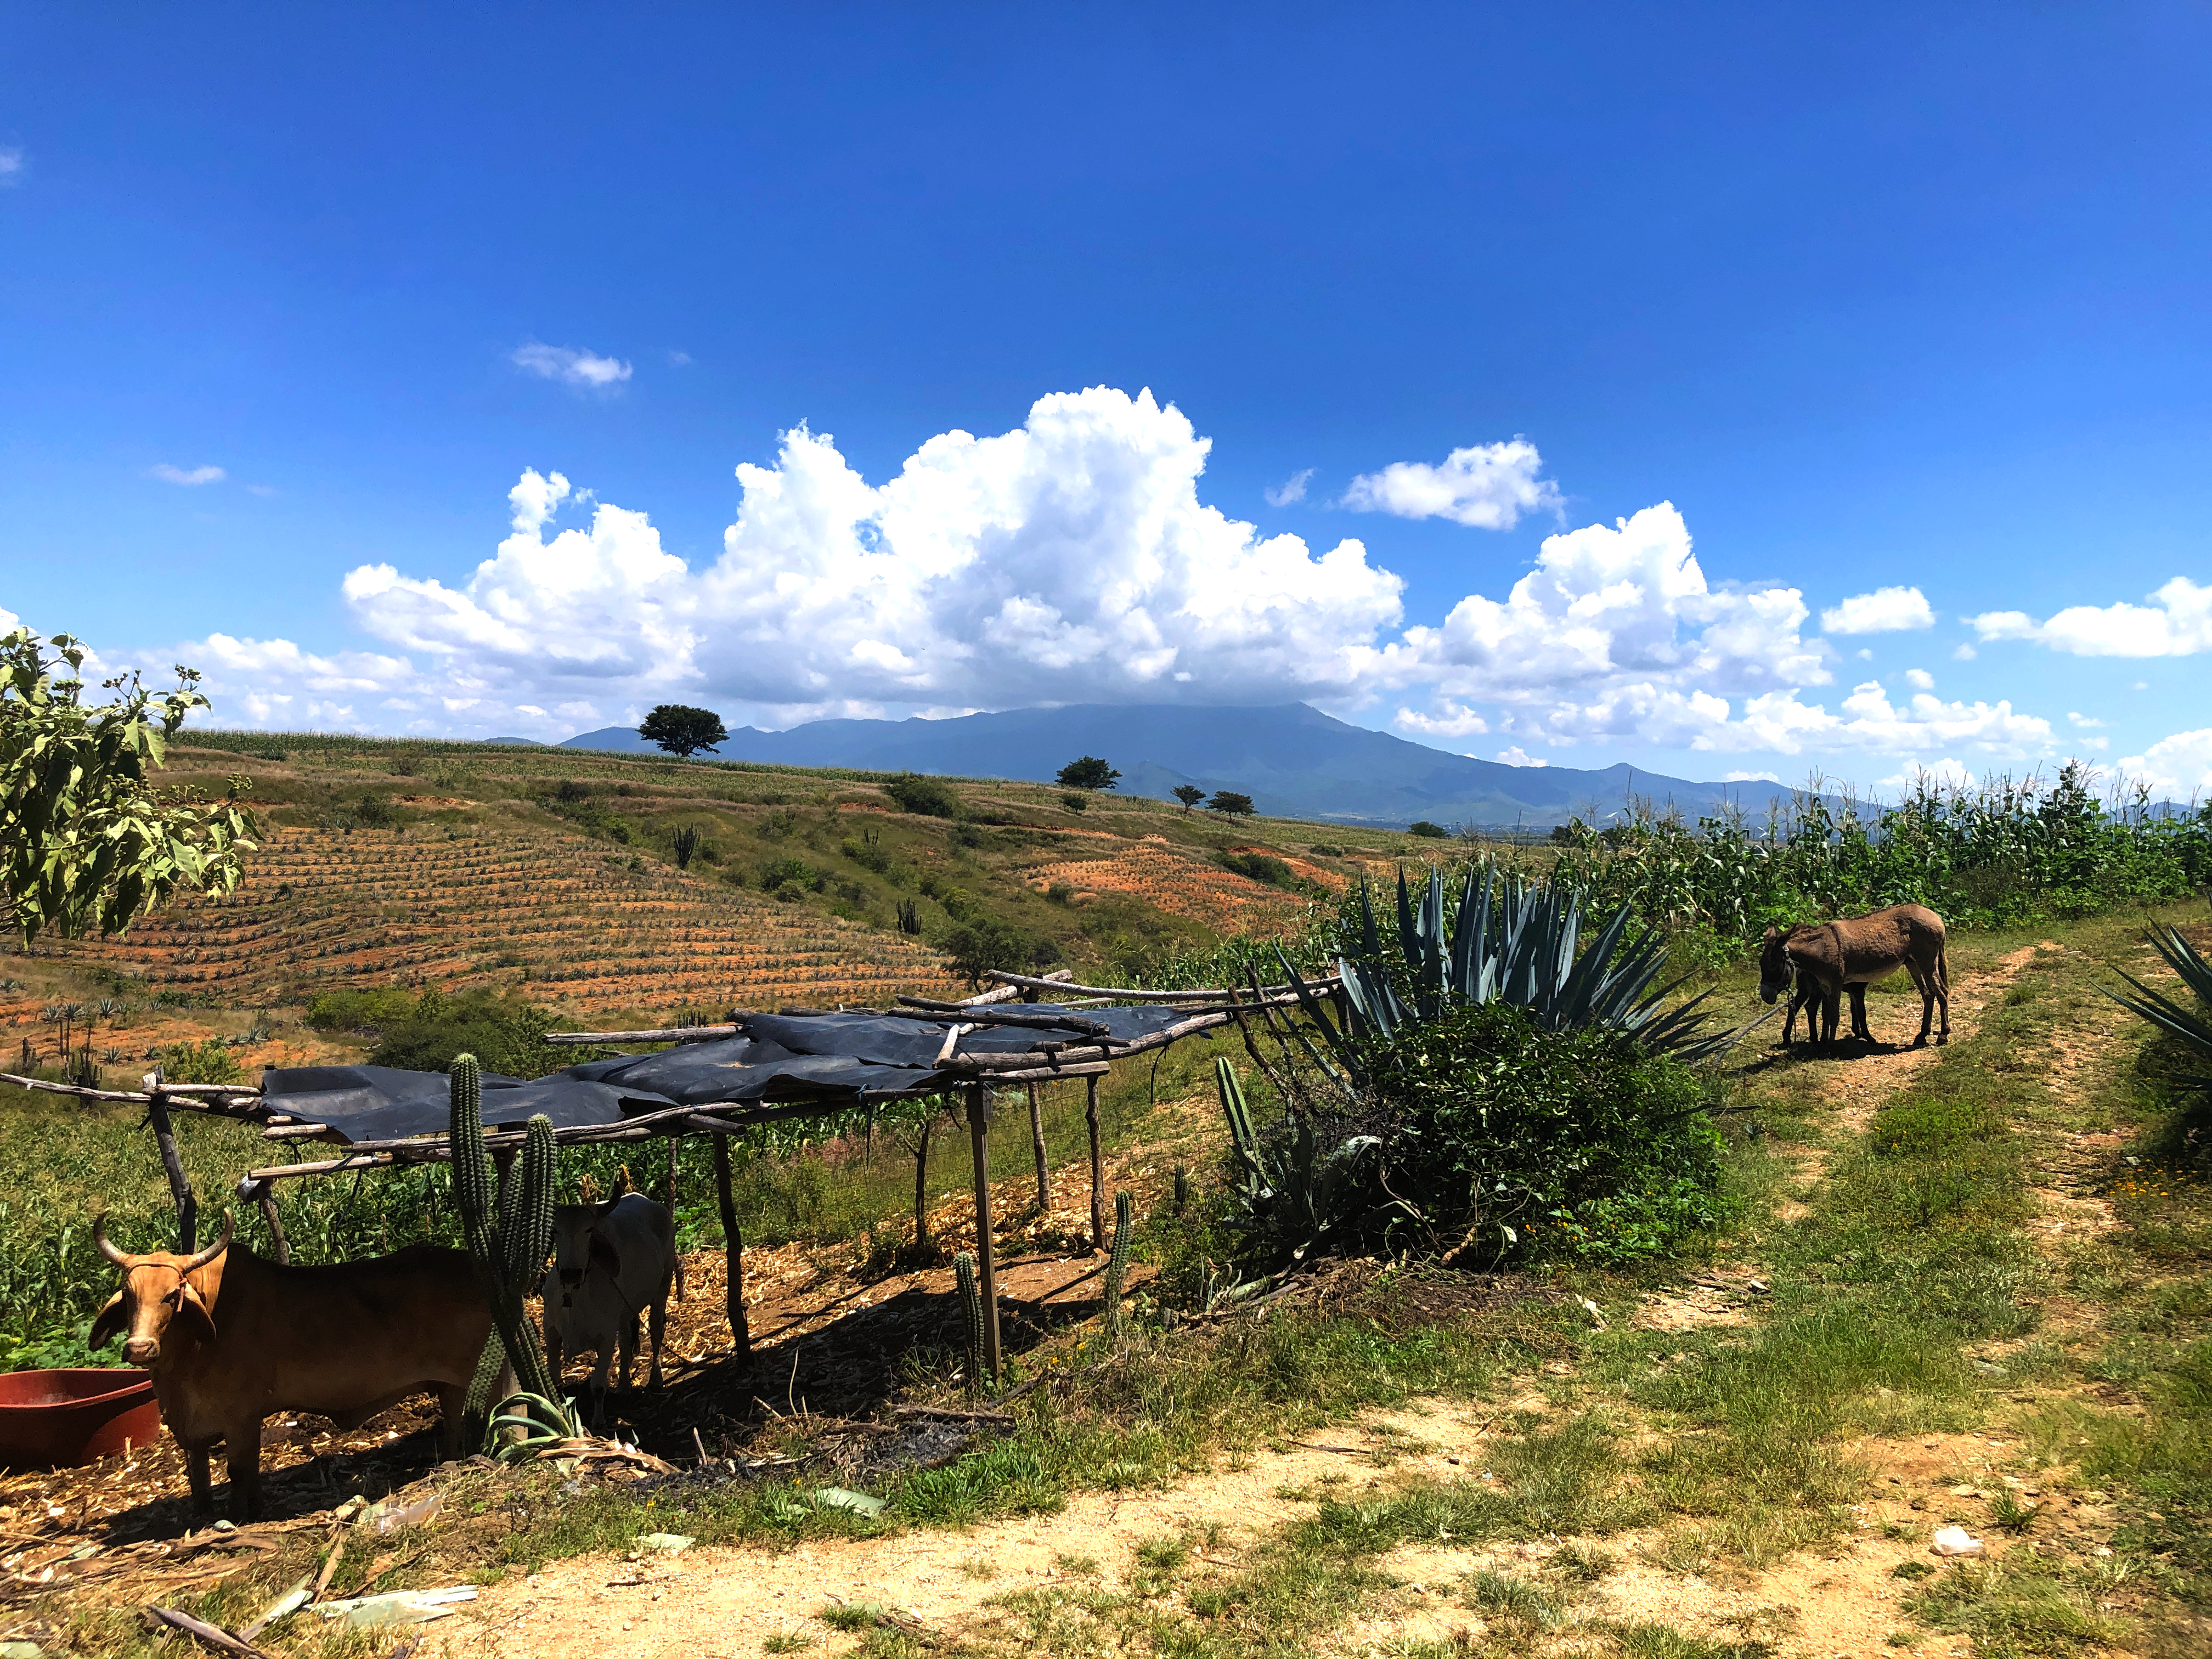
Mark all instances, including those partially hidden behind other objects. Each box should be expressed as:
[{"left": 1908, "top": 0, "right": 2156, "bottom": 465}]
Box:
[{"left": 506, "top": 703, "right": 1787, "bottom": 830}]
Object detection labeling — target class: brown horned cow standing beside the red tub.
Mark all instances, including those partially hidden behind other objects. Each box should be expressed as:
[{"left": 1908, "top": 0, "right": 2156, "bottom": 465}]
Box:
[{"left": 88, "top": 1210, "right": 513, "bottom": 1522}]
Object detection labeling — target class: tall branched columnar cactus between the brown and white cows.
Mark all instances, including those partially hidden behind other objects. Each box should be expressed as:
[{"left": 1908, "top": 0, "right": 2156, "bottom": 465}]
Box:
[{"left": 449, "top": 1055, "right": 560, "bottom": 1402}]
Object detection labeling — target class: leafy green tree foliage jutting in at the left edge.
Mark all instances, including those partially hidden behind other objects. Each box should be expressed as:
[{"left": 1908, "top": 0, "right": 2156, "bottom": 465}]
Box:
[{"left": 0, "top": 628, "right": 257, "bottom": 945}]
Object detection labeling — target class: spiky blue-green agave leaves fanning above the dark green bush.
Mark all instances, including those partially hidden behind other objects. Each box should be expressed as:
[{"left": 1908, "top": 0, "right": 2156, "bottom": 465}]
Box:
[{"left": 1276, "top": 862, "right": 1756, "bottom": 1082}]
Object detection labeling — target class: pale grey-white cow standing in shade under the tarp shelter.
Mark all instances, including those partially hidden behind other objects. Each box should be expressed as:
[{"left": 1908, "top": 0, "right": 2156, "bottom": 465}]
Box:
[{"left": 538, "top": 1192, "right": 677, "bottom": 1400}]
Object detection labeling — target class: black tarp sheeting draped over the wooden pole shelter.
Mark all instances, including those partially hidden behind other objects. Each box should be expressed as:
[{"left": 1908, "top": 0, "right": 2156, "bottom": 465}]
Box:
[{"left": 261, "top": 1005, "right": 1188, "bottom": 1144}]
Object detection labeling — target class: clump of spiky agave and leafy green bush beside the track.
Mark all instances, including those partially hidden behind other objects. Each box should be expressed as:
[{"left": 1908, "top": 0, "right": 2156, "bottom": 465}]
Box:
[{"left": 1217, "top": 865, "right": 1765, "bottom": 1269}]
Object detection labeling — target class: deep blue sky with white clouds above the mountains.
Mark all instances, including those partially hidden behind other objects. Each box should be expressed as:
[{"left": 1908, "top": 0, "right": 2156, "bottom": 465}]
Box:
[{"left": 0, "top": 4, "right": 2212, "bottom": 794}]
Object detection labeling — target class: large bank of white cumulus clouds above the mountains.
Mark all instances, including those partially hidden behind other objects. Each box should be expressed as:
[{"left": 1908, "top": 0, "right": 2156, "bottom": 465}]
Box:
[{"left": 60, "top": 387, "right": 2088, "bottom": 783}]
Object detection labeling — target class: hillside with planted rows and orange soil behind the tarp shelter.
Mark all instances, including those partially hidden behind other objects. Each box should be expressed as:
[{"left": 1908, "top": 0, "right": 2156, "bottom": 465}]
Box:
[{"left": 15, "top": 735, "right": 1418, "bottom": 1026}]
